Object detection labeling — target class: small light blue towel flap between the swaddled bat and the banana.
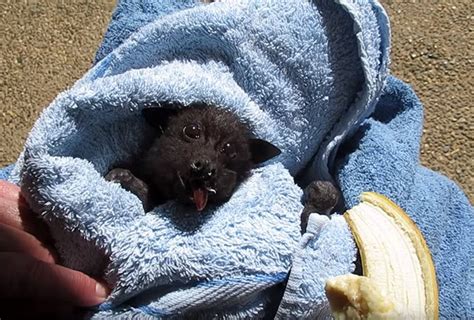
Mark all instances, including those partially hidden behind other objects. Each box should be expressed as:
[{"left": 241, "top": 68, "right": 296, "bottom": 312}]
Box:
[{"left": 276, "top": 214, "right": 356, "bottom": 319}]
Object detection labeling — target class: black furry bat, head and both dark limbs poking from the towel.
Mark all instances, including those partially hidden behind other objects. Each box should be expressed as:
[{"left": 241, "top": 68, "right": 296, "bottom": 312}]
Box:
[{"left": 106, "top": 104, "right": 340, "bottom": 232}]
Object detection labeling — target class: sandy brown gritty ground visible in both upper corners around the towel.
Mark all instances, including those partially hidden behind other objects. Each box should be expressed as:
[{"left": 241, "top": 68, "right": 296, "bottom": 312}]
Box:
[{"left": 0, "top": 0, "right": 474, "bottom": 203}]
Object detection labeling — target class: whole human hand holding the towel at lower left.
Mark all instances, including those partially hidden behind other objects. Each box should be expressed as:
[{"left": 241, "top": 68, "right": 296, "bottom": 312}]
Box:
[{"left": 0, "top": 180, "right": 108, "bottom": 319}]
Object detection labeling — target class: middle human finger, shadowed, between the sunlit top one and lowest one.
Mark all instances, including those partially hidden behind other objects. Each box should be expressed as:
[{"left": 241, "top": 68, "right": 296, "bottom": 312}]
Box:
[{"left": 0, "top": 223, "right": 56, "bottom": 263}]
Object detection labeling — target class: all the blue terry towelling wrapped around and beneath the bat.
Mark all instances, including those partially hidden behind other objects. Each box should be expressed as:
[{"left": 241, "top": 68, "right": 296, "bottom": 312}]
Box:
[{"left": 2, "top": 0, "right": 474, "bottom": 319}]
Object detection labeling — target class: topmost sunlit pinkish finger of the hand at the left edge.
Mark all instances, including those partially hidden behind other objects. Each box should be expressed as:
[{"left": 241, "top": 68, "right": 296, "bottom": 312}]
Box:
[{"left": 0, "top": 180, "right": 49, "bottom": 241}]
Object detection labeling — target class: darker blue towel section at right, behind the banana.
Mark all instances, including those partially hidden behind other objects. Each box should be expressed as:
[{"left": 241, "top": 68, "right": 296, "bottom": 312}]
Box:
[{"left": 337, "top": 77, "right": 474, "bottom": 319}]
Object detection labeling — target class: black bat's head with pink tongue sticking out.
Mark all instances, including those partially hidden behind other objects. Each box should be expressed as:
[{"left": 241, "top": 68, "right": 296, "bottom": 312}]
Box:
[{"left": 142, "top": 106, "right": 280, "bottom": 211}]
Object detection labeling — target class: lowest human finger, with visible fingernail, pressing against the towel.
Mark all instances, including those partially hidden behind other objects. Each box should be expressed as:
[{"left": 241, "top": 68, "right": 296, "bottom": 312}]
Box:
[{"left": 0, "top": 253, "right": 108, "bottom": 306}]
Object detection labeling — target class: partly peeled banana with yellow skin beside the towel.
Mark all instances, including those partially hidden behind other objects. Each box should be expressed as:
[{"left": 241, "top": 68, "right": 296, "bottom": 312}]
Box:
[{"left": 326, "top": 192, "right": 438, "bottom": 319}]
